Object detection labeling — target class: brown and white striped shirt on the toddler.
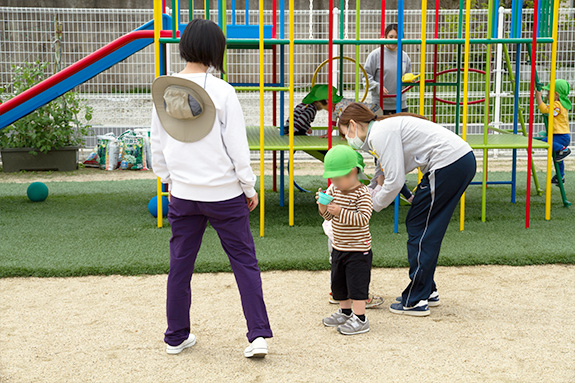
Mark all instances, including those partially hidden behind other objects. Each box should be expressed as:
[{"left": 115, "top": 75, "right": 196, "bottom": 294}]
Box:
[{"left": 321, "top": 184, "right": 373, "bottom": 251}]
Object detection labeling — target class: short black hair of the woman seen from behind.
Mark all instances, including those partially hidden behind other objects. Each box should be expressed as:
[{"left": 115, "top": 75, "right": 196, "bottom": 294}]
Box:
[{"left": 180, "top": 19, "right": 226, "bottom": 73}]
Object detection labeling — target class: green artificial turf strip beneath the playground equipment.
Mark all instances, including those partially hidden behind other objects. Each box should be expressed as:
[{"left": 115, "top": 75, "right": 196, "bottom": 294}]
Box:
[{"left": 0, "top": 172, "right": 575, "bottom": 277}]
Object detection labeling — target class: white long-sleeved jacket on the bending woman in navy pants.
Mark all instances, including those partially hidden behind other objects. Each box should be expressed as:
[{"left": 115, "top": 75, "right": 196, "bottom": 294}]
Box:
[{"left": 362, "top": 116, "right": 472, "bottom": 211}]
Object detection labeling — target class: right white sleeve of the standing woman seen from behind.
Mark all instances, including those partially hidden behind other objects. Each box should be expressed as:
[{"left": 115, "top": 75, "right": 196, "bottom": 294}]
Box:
[{"left": 221, "top": 91, "right": 256, "bottom": 198}]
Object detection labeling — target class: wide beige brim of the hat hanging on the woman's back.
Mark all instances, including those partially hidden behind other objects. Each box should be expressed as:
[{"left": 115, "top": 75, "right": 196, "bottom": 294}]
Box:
[{"left": 152, "top": 76, "right": 216, "bottom": 142}]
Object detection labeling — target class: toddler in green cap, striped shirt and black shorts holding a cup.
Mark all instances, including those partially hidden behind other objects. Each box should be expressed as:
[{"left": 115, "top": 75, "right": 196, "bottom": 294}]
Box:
[{"left": 316, "top": 145, "right": 373, "bottom": 335}]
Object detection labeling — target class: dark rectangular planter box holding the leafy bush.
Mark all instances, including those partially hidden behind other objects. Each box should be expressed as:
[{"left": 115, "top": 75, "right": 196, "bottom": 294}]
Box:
[{"left": 2, "top": 146, "right": 79, "bottom": 173}]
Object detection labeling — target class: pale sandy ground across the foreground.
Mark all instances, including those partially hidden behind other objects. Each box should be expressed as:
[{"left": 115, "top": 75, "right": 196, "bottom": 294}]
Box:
[{"left": 0, "top": 265, "right": 575, "bottom": 383}]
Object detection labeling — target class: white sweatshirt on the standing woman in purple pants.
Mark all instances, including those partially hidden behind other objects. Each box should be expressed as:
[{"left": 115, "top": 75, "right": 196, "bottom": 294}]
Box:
[{"left": 150, "top": 73, "right": 256, "bottom": 202}]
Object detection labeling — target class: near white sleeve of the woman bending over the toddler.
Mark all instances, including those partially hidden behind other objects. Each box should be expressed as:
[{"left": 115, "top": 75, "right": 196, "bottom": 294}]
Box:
[{"left": 373, "top": 129, "right": 405, "bottom": 211}]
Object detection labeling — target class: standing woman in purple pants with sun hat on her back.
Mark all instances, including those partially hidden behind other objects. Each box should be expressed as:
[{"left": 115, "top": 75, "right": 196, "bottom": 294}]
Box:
[{"left": 151, "top": 19, "right": 272, "bottom": 358}]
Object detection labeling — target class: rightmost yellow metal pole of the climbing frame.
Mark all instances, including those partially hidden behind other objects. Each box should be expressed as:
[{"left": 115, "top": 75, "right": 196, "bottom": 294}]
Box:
[{"left": 545, "top": 0, "right": 560, "bottom": 221}]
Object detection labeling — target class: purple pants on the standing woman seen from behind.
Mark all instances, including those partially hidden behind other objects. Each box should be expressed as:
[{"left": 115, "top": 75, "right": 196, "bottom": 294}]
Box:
[{"left": 164, "top": 194, "right": 273, "bottom": 346}]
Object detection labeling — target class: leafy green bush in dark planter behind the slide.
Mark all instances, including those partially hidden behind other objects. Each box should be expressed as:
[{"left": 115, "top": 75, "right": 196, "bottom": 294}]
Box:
[{"left": 0, "top": 61, "right": 92, "bottom": 172}]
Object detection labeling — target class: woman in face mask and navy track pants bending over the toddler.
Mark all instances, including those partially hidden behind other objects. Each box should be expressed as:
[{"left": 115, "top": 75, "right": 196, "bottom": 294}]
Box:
[{"left": 339, "top": 103, "right": 477, "bottom": 316}]
